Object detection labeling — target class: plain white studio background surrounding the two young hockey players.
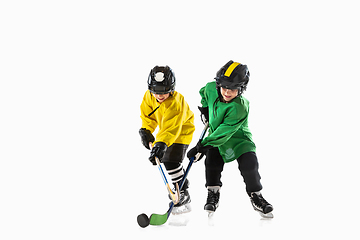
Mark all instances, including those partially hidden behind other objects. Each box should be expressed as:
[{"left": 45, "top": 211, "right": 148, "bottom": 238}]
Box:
[{"left": 0, "top": 0, "right": 360, "bottom": 239}]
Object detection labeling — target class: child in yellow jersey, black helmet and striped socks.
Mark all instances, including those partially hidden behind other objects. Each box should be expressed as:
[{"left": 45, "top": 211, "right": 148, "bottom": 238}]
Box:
[{"left": 139, "top": 66, "right": 195, "bottom": 211}]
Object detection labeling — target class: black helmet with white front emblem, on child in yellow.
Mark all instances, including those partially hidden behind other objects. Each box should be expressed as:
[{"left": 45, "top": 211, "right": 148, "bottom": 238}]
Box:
[{"left": 148, "top": 66, "right": 175, "bottom": 94}]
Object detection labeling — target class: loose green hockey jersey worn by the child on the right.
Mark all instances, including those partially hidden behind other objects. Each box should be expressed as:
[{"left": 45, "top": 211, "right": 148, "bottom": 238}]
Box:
[{"left": 199, "top": 82, "right": 256, "bottom": 162}]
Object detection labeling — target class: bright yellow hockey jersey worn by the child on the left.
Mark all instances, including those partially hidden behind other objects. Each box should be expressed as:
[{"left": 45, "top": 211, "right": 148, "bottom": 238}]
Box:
[{"left": 140, "top": 91, "right": 195, "bottom": 147}]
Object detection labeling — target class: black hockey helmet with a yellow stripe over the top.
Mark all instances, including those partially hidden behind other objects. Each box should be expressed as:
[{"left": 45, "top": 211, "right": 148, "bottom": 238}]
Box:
[{"left": 215, "top": 60, "right": 250, "bottom": 95}]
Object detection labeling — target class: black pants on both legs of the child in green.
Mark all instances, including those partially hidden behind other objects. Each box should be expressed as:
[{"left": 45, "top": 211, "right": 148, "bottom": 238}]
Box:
[{"left": 205, "top": 147, "right": 262, "bottom": 196}]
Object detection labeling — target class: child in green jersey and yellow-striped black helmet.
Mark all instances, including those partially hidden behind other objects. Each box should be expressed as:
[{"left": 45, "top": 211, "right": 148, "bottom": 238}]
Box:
[{"left": 188, "top": 61, "right": 273, "bottom": 217}]
